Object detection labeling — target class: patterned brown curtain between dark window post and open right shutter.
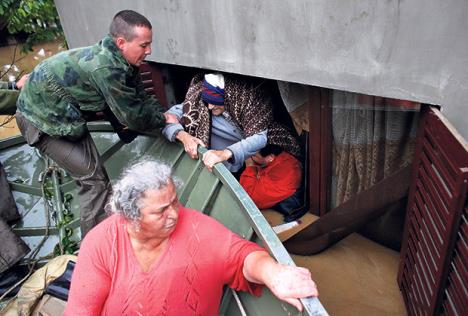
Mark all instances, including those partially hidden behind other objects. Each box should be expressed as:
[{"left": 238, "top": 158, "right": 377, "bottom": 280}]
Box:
[{"left": 331, "top": 90, "right": 419, "bottom": 208}]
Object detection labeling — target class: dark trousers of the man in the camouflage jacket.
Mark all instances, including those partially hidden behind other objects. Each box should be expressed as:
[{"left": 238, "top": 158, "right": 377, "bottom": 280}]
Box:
[{"left": 16, "top": 112, "right": 112, "bottom": 237}]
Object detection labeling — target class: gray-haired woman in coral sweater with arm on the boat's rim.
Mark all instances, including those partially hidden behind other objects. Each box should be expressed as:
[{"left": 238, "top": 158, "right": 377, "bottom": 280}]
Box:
[{"left": 65, "top": 161, "right": 318, "bottom": 315}]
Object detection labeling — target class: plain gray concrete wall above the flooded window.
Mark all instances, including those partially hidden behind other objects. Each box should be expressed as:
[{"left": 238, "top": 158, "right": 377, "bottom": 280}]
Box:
[{"left": 55, "top": 0, "right": 468, "bottom": 138}]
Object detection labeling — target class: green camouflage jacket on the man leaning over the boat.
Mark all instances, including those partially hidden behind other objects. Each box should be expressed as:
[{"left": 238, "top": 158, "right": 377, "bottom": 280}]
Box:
[{"left": 17, "top": 35, "right": 165, "bottom": 138}]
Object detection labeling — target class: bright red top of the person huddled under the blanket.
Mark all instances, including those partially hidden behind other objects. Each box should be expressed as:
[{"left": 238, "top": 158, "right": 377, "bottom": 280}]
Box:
[{"left": 240, "top": 152, "right": 301, "bottom": 209}]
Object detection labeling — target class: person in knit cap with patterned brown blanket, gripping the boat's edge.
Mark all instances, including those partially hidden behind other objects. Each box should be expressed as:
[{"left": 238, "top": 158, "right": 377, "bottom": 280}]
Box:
[{"left": 163, "top": 74, "right": 300, "bottom": 172}]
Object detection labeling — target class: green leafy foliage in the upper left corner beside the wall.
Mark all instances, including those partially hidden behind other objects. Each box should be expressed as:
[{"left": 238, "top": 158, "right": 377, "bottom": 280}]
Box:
[{"left": 0, "top": 0, "right": 64, "bottom": 52}]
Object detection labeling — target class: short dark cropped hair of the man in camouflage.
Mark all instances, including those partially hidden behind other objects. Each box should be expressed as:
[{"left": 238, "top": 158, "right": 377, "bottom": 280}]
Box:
[{"left": 109, "top": 10, "right": 153, "bottom": 41}]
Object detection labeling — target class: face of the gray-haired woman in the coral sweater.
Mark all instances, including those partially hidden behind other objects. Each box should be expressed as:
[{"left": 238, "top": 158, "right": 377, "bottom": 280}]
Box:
[{"left": 136, "top": 180, "right": 180, "bottom": 238}]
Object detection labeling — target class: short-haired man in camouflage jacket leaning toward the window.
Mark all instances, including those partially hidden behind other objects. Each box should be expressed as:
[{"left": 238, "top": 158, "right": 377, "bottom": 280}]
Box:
[{"left": 16, "top": 10, "right": 176, "bottom": 236}]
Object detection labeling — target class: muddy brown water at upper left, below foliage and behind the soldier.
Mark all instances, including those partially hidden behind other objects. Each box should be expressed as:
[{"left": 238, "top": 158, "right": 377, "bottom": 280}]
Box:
[{"left": 0, "top": 42, "right": 65, "bottom": 139}]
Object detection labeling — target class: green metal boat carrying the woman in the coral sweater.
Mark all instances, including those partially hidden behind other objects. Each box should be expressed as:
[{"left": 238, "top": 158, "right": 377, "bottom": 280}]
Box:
[{"left": 0, "top": 122, "right": 327, "bottom": 315}]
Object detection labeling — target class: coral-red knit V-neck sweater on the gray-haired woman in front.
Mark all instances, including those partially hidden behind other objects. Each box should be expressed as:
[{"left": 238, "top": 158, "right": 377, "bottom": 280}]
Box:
[{"left": 64, "top": 207, "right": 263, "bottom": 316}]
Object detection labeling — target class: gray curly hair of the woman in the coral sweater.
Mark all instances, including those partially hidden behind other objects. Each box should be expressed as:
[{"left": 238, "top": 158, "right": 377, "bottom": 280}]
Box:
[{"left": 106, "top": 158, "right": 182, "bottom": 223}]
